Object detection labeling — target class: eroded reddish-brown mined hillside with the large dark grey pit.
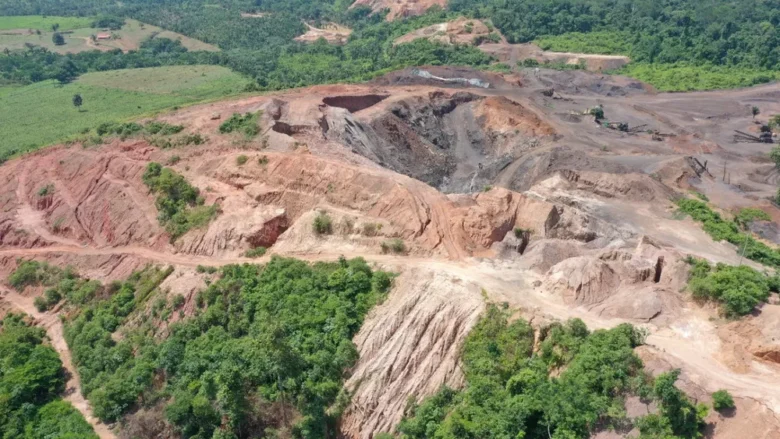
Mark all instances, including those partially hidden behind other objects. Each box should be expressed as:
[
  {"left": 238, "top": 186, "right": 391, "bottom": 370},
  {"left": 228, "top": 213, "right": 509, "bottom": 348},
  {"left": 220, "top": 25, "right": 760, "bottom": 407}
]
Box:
[{"left": 0, "top": 67, "right": 780, "bottom": 438}]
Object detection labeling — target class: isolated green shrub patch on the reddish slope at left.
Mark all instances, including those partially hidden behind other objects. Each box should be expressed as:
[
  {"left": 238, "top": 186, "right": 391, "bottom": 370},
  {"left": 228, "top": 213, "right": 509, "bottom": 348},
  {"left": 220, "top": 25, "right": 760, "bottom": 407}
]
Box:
[{"left": 143, "top": 162, "right": 218, "bottom": 240}]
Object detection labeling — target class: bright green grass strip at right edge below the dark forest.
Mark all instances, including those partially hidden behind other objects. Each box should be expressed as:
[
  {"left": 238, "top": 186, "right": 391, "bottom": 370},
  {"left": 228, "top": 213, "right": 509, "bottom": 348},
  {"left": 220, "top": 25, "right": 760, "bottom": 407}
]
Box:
[{"left": 612, "top": 63, "right": 780, "bottom": 91}]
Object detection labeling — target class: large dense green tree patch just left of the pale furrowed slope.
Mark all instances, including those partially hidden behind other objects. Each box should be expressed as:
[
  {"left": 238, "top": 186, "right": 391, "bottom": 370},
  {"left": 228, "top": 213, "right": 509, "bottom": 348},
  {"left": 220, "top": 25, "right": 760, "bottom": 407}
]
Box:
[{"left": 55, "top": 258, "right": 391, "bottom": 438}]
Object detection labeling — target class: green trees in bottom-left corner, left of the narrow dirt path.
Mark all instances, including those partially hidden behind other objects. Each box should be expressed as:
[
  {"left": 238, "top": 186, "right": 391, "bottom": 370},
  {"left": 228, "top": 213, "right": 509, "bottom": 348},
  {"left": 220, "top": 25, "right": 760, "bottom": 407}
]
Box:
[{"left": 0, "top": 314, "right": 98, "bottom": 439}]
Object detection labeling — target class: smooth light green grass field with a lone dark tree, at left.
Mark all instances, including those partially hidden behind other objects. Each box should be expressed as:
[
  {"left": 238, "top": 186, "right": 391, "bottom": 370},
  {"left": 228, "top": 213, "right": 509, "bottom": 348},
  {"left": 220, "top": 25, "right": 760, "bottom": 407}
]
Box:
[{"left": 0, "top": 66, "right": 247, "bottom": 157}]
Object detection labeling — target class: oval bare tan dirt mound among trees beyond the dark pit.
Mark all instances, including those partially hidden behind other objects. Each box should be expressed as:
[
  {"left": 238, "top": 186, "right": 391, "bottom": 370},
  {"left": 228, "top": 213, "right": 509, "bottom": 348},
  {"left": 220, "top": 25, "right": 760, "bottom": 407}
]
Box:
[{"left": 393, "top": 17, "right": 506, "bottom": 45}]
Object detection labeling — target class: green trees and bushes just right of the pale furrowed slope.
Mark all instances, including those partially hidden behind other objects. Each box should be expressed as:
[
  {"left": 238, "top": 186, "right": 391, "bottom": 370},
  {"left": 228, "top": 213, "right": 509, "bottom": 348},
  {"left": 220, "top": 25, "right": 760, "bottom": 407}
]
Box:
[{"left": 398, "top": 304, "right": 707, "bottom": 439}]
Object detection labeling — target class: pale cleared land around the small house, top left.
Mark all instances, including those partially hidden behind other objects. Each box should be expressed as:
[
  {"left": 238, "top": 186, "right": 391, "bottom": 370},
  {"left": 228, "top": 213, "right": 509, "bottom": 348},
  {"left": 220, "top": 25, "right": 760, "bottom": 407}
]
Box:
[{"left": 0, "top": 17, "right": 219, "bottom": 53}]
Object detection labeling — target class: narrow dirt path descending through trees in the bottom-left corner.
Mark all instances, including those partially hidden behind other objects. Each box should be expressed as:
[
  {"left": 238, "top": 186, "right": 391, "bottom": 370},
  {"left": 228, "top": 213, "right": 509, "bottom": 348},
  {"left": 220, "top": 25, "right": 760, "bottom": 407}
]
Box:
[{"left": 0, "top": 287, "right": 116, "bottom": 439}]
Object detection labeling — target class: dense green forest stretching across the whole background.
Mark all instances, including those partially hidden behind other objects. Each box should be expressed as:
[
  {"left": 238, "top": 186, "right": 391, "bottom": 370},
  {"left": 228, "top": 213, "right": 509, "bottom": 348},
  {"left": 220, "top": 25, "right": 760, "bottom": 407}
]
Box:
[{"left": 6, "top": 0, "right": 780, "bottom": 90}]
